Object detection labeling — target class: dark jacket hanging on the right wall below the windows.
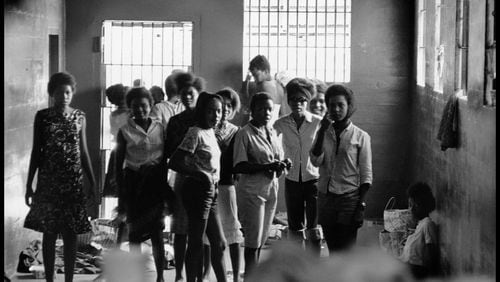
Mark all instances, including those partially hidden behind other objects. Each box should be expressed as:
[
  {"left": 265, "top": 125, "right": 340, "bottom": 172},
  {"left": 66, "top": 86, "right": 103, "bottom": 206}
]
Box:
[{"left": 437, "top": 93, "right": 458, "bottom": 151}]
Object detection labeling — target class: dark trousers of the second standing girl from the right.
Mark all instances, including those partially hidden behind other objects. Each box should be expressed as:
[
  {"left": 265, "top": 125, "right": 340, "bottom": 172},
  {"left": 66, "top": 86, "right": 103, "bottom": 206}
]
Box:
[{"left": 285, "top": 179, "right": 318, "bottom": 231}]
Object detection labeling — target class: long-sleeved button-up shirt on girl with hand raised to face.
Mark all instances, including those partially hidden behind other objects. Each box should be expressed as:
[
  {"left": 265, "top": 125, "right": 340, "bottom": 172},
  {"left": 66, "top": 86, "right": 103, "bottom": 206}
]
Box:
[{"left": 310, "top": 122, "right": 373, "bottom": 194}]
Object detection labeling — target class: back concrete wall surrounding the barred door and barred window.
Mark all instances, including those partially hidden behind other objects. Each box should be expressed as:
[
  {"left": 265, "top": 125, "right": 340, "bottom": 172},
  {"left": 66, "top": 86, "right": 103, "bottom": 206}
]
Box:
[{"left": 67, "top": 0, "right": 413, "bottom": 218}]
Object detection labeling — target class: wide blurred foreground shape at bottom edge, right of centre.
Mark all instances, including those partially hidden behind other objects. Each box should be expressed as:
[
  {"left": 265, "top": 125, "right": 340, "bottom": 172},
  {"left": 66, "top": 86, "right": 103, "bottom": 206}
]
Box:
[{"left": 245, "top": 241, "right": 415, "bottom": 282}]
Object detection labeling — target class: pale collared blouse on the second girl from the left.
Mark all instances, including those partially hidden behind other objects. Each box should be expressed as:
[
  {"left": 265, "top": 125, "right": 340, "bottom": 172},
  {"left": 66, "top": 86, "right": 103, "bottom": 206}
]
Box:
[{"left": 120, "top": 118, "right": 165, "bottom": 170}]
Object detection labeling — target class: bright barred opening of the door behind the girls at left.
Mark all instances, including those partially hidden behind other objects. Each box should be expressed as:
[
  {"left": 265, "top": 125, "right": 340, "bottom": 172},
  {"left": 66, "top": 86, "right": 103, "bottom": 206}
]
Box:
[{"left": 101, "top": 21, "right": 193, "bottom": 91}]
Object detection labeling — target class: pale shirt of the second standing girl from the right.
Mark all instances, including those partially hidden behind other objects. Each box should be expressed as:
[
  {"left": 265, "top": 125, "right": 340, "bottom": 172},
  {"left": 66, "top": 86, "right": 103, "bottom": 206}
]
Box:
[{"left": 274, "top": 111, "right": 321, "bottom": 182}]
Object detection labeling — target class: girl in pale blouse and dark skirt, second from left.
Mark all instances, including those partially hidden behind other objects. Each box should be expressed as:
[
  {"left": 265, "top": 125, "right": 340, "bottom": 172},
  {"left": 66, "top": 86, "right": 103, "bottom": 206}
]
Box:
[{"left": 116, "top": 87, "right": 173, "bottom": 282}]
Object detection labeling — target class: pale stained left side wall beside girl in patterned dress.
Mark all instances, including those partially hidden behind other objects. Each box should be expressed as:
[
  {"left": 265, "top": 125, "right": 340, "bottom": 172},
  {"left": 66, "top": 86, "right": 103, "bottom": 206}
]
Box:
[{"left": 4, "top": 0, "right": 64, "bottom": 274}]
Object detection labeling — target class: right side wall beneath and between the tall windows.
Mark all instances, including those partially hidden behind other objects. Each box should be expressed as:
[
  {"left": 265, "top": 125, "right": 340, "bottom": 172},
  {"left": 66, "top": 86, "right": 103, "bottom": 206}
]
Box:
[{"left": 411, "top": 1, "right": 496, "bottom": 277}]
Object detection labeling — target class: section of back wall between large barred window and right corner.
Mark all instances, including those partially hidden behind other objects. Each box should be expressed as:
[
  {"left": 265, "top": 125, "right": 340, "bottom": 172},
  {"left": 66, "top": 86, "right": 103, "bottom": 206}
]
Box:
[{"left": 348, "top": 0, "right": 413, "bottom": 218}]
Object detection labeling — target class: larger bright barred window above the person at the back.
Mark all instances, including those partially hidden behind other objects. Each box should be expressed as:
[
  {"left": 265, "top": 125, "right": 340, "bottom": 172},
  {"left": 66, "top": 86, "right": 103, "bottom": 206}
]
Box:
[{"left": 243, "top": 0, "right": 351, "bottom": 82}]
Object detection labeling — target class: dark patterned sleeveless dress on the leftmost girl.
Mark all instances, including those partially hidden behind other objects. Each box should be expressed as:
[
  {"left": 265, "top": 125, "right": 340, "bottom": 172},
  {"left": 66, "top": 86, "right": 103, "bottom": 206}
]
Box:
[{"left": 24, "top": 108, "right": 91, "bottom": 234}]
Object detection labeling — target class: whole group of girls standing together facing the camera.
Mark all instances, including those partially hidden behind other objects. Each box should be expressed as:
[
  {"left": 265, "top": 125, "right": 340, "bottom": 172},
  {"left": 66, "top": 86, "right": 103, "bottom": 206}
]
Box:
[{"left": 25, "top": 62, "right": 372, "bottom": 281}]
